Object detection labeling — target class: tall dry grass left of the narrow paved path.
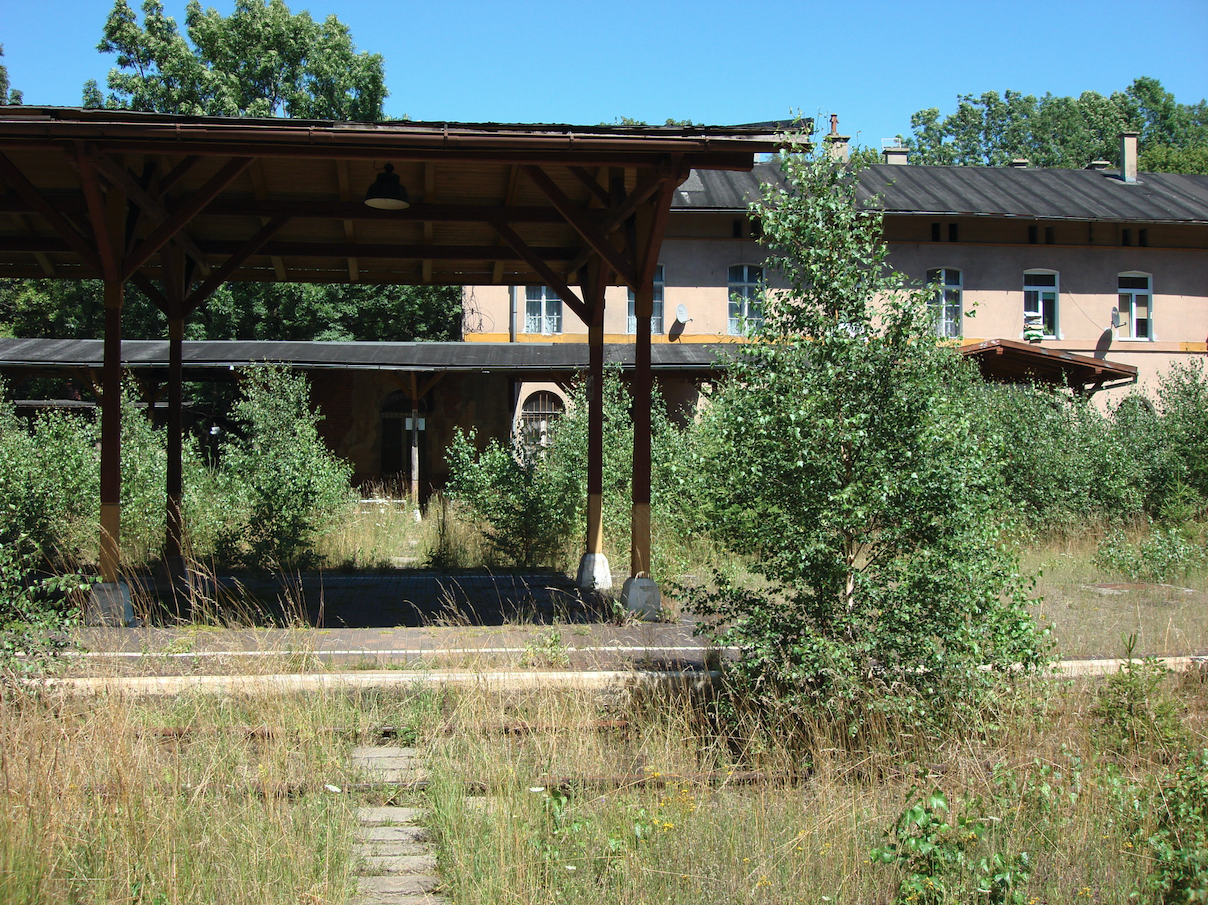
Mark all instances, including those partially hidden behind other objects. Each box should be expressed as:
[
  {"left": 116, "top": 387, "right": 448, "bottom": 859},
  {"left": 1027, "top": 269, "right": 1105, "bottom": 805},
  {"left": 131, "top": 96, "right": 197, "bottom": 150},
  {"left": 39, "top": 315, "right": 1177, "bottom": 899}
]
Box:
[{"left": 0, "top": 690, "right": 434, "bottom": 905}]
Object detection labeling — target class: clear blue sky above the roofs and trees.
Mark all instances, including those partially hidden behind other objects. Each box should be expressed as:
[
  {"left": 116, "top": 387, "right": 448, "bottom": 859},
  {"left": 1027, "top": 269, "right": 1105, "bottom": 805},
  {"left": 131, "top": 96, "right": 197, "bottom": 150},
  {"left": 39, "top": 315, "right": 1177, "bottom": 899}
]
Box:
[{"left": 0, "top": 0, "right": 1208, "bottom": 145}]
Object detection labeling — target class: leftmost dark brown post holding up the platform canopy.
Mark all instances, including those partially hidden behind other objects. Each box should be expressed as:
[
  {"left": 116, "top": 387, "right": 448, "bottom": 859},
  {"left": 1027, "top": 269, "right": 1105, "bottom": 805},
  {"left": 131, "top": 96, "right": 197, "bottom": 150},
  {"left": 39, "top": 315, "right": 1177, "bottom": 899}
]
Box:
[{"left": 100, "top": 279, "right": 126, "bottom": 584}]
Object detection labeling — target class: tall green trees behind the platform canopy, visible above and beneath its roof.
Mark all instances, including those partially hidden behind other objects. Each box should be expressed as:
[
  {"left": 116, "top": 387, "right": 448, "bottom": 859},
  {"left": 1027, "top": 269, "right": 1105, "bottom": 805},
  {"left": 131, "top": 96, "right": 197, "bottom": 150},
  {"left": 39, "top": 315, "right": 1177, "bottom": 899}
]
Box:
[{"left": 9, "top": 0, "right": 461, "bottom": 350}]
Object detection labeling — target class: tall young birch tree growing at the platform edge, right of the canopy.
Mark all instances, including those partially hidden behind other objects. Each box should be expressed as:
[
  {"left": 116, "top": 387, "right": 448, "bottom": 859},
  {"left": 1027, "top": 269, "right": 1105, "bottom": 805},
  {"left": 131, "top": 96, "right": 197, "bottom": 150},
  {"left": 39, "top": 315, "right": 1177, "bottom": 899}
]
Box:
[{"left": 690, "top": 141, "right": 1041, "bottom": 733}]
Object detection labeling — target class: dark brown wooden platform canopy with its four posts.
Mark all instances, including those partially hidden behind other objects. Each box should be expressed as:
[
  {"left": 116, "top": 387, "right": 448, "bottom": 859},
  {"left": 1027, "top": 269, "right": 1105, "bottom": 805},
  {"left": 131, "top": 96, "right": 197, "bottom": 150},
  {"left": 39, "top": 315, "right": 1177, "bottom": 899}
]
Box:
[{"left": 0, "top": 106, "right": 779, "bottom": 581}]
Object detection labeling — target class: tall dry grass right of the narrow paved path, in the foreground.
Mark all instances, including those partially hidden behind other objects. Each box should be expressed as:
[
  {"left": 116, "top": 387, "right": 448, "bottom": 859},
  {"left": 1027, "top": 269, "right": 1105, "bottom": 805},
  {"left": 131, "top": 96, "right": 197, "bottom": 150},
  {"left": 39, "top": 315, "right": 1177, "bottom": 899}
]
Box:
[{"left": 428, "top": 675, "right": 1208, "bottom": 905}]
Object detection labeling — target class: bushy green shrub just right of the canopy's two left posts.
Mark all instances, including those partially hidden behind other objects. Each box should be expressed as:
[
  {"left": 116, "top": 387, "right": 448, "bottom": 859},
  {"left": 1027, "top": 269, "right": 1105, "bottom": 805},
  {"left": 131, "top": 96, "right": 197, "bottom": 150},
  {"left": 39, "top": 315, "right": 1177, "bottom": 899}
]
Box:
[{"left": 220, "top": 366, "right": 352, "bottom": 568}]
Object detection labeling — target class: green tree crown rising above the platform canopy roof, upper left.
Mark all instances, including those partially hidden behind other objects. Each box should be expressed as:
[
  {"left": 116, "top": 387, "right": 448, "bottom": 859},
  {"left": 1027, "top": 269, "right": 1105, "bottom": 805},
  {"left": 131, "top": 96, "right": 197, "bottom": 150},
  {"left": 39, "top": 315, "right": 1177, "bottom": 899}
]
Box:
[{"left": 83, "top": 0, "right": 387, "bottom": 122}]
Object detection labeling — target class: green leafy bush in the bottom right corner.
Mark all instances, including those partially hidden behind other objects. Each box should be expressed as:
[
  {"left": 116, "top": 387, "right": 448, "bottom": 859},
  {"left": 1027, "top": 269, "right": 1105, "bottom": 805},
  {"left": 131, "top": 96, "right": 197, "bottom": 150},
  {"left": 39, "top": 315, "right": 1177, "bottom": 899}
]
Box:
[{"left": 1149, "top": 750, "right": 1208, "bottom": 905}]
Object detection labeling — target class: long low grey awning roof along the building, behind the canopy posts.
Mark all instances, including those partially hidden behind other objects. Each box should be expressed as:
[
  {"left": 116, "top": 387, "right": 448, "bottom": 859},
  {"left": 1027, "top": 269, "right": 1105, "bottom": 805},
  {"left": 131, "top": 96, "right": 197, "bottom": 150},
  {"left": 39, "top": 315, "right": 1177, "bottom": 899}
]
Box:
[{"left": 0, "top": 340, "right": 730, "bottom": 372}]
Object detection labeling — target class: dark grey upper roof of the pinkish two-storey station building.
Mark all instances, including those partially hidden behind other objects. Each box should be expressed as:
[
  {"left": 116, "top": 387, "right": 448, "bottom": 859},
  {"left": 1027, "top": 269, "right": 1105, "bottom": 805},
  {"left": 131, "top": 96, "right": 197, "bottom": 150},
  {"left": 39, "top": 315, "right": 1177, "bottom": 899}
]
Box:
[{"left": 672, "top": 161, "right": 1208, "bottom": 224}]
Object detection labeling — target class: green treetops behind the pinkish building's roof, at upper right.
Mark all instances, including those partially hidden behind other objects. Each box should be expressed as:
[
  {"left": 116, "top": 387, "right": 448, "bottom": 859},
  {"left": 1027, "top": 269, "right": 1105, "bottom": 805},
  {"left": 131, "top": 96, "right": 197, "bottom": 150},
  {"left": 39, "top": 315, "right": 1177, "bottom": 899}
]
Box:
[{"left": 906, "top": 76, "right": 1208, "bottom": 173}]
